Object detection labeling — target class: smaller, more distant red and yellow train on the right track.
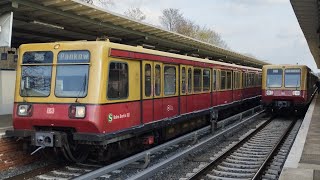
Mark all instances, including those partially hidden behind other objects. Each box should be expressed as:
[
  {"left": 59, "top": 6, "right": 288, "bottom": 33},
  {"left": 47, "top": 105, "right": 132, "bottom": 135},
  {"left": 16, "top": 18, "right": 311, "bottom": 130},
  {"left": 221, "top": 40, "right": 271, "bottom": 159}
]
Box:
[{"left": 262, "top": 65, "right": 319, "bottom": 112}]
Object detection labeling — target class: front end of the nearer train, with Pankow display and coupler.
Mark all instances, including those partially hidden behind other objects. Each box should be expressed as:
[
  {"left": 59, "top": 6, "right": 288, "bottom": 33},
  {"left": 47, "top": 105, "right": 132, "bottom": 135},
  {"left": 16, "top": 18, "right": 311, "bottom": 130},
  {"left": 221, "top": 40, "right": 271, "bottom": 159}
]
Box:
[{"left": 6, "top": 41, "right": 107, "bottom": 161}]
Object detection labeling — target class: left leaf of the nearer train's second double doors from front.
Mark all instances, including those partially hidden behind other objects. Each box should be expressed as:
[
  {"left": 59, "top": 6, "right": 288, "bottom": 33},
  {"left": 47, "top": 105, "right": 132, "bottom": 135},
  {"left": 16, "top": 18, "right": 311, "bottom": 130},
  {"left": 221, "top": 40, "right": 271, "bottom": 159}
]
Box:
[{"left": 180, "top": 65, "right": 187, "bottom": 114}]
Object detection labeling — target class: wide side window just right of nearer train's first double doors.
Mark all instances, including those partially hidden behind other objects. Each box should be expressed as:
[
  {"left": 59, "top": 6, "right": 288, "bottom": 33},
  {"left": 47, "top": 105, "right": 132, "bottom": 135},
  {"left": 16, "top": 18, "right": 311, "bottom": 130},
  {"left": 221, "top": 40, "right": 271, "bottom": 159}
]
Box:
[{"left": 164, "top": 66, "right": 176, "bottom": 95}]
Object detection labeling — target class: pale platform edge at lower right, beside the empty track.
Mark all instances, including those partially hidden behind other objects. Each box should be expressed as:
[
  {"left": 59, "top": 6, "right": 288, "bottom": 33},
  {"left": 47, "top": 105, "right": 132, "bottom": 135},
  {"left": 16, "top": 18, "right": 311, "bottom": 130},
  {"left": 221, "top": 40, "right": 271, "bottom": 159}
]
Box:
[{"left": 279, "top": 95, "right": 320, "bottom": 180}]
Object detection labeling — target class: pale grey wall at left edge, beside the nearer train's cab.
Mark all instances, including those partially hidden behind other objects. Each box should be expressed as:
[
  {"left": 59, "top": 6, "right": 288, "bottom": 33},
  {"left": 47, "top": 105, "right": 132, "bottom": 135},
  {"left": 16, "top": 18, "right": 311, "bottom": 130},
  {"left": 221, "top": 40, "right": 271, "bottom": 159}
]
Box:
[{"left": 0, "top": 70, "right": 16, "bottom": 115}]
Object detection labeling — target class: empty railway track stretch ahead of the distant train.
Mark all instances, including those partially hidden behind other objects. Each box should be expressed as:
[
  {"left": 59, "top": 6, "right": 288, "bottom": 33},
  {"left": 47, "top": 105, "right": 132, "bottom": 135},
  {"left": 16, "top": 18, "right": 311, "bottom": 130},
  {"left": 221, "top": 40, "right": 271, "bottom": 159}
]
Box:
[{"left": 181, "top": 118, "right": 300, "bottom": 180}]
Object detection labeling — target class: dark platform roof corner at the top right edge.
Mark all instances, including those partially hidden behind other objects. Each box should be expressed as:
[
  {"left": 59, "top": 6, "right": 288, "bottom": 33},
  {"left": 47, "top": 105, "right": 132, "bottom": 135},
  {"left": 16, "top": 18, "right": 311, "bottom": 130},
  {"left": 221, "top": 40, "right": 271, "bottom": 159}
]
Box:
[{"left": 290, "top": 0, "right": 320, "bottom": 69}]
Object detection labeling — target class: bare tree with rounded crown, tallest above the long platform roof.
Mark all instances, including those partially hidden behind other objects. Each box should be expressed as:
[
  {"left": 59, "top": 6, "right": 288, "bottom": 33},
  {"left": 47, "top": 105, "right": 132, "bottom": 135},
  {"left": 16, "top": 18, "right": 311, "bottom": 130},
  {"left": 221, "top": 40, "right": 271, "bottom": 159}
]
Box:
[{"left": 159, "top": 8, "right": 184, "bottom": 32}]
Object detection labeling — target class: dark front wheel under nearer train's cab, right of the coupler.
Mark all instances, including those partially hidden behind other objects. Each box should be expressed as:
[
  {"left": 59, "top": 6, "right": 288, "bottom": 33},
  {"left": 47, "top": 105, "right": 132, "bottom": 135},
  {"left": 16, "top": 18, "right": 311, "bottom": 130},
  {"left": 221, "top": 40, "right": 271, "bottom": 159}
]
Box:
[{"left": 61, "top": 143, "right": 89, "bottom": 163}]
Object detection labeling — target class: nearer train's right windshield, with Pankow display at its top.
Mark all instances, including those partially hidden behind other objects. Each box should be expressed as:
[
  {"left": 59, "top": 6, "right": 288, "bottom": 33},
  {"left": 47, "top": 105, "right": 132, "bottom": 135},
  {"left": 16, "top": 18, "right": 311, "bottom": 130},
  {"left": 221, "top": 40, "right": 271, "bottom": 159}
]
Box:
[{"left": 55, "top": 51, "right": 90, "bottom": 98}]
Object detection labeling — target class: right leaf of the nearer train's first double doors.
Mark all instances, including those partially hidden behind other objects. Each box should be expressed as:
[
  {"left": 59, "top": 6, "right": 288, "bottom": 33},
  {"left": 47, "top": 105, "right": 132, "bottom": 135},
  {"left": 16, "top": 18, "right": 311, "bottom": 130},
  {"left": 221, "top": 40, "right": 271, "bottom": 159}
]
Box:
[{"left": 153, "top": 62, "right": 163, "bottom": 121}]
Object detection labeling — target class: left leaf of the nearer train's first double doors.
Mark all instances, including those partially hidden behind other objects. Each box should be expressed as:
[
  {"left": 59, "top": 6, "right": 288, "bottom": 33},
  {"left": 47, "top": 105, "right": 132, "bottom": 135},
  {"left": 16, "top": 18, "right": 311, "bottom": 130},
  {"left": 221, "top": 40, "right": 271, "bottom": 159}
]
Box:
[{"left": 142, "top": 61, "right": 154, "bottom": 123}]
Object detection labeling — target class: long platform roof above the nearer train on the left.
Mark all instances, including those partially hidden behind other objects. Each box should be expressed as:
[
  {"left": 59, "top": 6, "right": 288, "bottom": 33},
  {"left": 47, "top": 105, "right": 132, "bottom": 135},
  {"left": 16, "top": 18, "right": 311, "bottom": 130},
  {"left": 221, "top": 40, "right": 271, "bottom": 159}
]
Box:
[{"left": 0, "top": 0, "right": 268, "bottom": 67}]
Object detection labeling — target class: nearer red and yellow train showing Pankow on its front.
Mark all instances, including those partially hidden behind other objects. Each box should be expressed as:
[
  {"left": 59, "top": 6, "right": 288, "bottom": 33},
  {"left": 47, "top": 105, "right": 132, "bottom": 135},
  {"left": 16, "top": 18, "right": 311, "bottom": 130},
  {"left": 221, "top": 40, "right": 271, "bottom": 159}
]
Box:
[{"left": 6, "top": 40, "right": 262, "bottom": 162}]
